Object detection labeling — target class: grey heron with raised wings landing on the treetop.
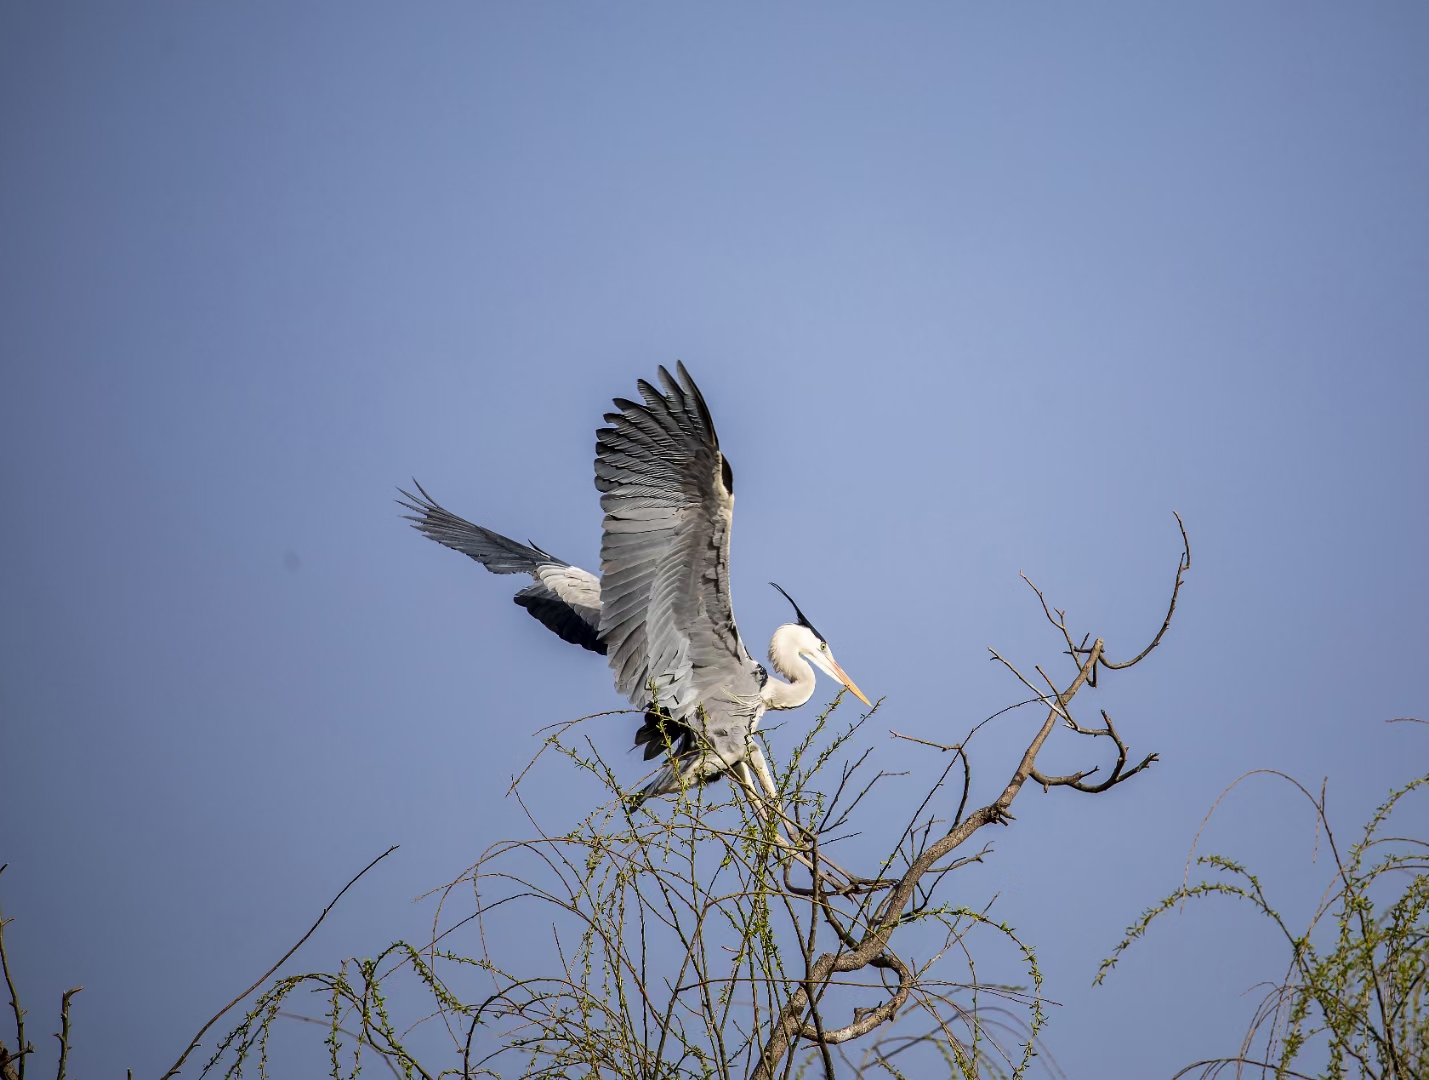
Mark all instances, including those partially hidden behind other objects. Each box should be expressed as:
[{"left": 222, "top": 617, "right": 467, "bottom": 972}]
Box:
[{"left": 402, "top": 363, "right": 869, "bottom": 800}]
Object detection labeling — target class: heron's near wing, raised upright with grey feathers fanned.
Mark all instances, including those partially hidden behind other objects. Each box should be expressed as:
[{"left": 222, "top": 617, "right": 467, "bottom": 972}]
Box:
[{"left": 596, "top": 364, "right": 759, "bottom": 737}]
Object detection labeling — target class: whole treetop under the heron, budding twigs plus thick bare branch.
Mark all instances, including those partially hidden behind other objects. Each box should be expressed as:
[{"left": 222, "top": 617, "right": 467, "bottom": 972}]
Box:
[{"left": 192, "top": 540, "right": 1190, "bottom": 1080}]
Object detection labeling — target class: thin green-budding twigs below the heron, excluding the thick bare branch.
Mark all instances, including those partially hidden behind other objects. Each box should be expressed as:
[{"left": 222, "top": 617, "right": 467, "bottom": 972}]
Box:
[{"left": 204, "top": 707, "right": 1046, "bottom": 1080}]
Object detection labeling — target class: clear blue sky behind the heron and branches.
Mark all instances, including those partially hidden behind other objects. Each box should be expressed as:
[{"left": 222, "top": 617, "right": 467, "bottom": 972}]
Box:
[{"left": 0, "top": 3, "right": 1429, "bottom": 1077}]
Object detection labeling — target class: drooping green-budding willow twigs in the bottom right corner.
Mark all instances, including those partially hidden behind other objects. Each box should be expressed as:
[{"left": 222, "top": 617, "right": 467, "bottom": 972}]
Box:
[{"left": 1096, "top": 770, "right": 1429, "bottom": 1080}]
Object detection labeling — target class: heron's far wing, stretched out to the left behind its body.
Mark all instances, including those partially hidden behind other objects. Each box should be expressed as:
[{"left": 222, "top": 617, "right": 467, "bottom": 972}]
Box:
[{"left": 397, "top": 480, "right": 606, "bottom": 653}]
